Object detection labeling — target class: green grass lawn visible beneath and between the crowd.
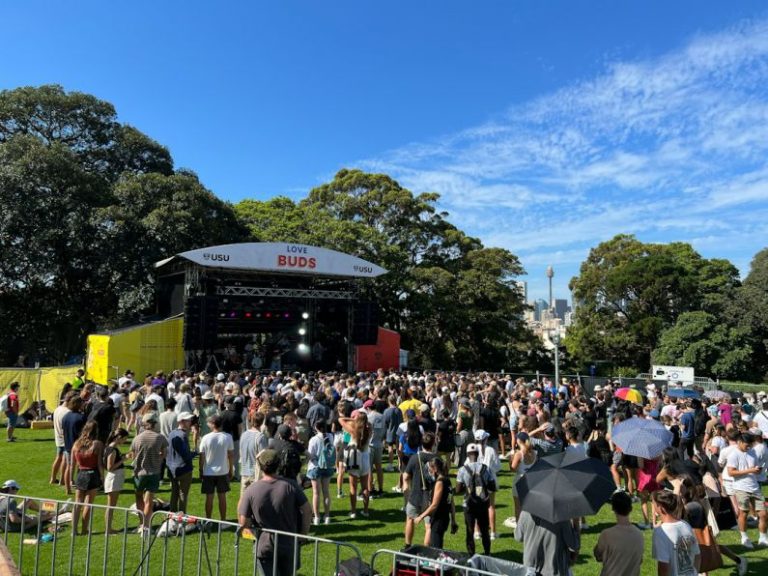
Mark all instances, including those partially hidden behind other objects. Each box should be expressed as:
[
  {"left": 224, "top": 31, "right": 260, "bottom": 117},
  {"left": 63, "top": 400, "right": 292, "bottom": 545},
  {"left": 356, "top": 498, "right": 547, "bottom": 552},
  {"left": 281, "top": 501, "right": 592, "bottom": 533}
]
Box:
[{"left": 0, "top": 430, "right": 768, "bottom": 576}]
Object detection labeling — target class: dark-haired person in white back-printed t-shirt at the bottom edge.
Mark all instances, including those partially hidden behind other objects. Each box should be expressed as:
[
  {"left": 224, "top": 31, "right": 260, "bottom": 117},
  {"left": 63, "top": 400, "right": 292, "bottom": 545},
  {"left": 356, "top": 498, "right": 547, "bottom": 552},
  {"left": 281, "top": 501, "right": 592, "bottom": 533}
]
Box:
[{"left": 651, "top": 490, "right": 701, "bottom": 576}]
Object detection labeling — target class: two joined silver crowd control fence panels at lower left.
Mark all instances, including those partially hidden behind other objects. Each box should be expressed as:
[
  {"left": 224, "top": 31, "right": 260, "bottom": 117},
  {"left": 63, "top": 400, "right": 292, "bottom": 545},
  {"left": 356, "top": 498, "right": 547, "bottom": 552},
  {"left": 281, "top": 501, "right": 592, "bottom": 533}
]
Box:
[{"left": 0, "top": 494, "right": 362, "bottom": 576}]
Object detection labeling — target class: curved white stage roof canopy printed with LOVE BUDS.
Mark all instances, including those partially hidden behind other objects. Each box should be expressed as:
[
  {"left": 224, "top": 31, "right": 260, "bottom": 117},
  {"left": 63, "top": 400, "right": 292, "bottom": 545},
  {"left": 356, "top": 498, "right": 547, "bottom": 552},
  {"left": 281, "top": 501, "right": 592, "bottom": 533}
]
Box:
[{"left": 155, "top": 242, "right": 387, "bottom": 278}]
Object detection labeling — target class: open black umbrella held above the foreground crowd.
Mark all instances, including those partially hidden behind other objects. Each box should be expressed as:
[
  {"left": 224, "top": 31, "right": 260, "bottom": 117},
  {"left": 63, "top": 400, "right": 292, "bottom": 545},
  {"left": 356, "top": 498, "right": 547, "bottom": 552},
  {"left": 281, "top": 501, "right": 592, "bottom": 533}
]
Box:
[{"left": 516, "top": 452, "right": 616, "bottom": 523}]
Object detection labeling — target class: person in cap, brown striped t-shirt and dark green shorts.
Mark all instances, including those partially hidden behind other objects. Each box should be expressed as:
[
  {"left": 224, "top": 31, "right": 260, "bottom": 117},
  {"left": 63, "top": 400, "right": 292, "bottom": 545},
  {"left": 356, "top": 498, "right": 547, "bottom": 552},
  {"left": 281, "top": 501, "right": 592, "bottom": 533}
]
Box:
[{"left": 131, "top": 412, "right": 168, "bottom": 536}]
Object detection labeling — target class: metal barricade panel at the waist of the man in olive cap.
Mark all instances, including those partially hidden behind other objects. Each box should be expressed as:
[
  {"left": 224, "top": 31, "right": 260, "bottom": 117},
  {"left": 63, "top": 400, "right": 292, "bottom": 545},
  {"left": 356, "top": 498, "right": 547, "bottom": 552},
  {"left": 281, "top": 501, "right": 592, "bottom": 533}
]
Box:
[{"left": 137, "top": 512, "right": 362, "bottom": 576}]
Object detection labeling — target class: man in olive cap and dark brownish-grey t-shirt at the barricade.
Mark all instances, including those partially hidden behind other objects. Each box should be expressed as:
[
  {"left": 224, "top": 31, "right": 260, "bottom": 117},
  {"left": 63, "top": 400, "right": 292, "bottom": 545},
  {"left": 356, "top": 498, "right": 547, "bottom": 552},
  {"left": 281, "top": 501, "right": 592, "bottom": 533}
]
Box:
[{"left": 237, "top": 448, "right": 312, "bottom": 576}]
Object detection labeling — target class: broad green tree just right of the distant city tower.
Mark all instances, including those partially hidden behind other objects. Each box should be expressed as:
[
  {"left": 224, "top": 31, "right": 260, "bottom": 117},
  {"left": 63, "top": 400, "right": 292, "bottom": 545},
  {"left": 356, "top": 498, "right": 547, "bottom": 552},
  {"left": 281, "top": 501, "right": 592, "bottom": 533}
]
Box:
[{"left": 566, "top": 235, "right": 739, "bottom": 370}]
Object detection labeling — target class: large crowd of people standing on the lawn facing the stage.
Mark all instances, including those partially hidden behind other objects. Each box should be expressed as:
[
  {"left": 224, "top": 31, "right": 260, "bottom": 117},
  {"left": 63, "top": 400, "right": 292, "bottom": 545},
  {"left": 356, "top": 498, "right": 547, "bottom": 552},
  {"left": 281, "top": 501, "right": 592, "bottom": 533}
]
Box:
[{"left": 1, "top": 370, "right": 768, "bottom": 575}]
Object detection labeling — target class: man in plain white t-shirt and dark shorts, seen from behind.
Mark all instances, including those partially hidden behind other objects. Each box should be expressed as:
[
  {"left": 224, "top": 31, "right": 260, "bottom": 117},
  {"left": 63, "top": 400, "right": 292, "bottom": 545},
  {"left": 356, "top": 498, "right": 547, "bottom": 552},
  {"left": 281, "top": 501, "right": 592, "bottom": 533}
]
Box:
[{"left": 199, "top": 416, "right": 235, "bottom": 520}]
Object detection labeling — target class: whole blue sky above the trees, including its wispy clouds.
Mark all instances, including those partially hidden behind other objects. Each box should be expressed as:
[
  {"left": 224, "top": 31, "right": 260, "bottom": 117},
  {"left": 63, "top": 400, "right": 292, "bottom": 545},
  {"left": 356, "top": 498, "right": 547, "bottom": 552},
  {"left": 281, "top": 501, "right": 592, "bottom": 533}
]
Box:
[{"left": 0, "top": 0, "right": 768, "bottom": 297}]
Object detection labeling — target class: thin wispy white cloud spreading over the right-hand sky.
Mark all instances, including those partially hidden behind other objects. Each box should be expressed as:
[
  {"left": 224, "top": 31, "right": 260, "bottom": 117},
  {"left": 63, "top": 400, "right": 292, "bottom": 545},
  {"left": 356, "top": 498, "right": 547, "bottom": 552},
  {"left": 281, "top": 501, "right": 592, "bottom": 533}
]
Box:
[{"left": 362, "top": 21, "right": 768, "bottom": 296}]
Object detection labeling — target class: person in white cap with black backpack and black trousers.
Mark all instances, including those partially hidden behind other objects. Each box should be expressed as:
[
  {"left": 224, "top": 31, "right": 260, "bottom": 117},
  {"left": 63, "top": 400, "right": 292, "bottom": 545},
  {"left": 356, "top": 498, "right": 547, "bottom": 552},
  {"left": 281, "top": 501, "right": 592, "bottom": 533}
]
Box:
[{"left": 456, "top": 443, "right": 496, "bottom": 556}]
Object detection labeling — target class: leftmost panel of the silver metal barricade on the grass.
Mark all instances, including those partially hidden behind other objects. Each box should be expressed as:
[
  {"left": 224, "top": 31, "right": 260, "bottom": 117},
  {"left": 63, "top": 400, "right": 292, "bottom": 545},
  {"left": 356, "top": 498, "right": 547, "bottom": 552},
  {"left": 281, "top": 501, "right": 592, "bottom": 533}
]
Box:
[{"left": 0, "top": 494, "right": 145, "bottom": 576}]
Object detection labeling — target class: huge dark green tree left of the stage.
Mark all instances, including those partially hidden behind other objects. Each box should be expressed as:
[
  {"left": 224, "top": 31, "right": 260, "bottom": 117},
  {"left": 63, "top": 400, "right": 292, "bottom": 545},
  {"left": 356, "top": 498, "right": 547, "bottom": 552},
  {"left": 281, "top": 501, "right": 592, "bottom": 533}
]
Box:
[{"left": 0, "top": 86, "right": 245, "bottom": 362}]
